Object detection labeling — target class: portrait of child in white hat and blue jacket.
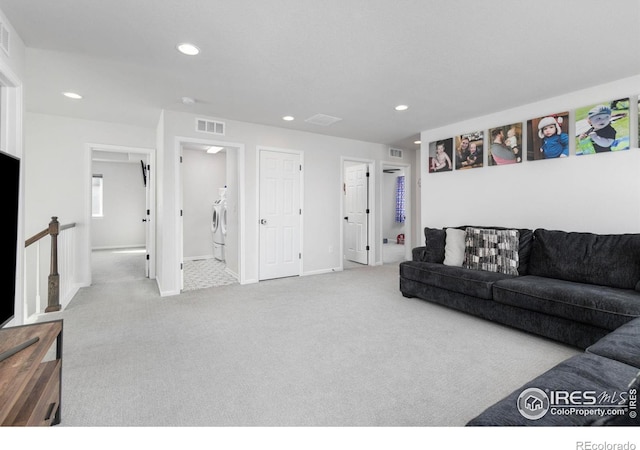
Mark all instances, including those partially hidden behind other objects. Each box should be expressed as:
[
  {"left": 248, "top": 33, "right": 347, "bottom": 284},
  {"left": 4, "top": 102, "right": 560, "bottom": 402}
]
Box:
[{"left": 527, "top": 111, "right": 569, "bottom": 161}]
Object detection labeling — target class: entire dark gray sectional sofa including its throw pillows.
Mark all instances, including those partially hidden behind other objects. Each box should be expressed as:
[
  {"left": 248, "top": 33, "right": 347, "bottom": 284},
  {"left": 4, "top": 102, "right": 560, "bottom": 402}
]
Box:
[{"left": 400, "top": 226, "right": 640, "bottom": 426}]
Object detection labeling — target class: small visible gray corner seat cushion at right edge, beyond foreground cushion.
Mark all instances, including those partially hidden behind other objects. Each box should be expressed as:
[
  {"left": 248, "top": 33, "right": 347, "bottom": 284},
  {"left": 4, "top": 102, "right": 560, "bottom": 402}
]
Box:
[{"left": 587, "top": 319, "right": 640, "bottom": 369}]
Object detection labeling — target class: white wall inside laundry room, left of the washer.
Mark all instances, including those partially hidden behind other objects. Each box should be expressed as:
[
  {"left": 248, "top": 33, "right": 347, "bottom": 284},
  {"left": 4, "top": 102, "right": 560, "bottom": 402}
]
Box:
[{"left": 182, "top": 150, "right": 227, "bottom": 260}]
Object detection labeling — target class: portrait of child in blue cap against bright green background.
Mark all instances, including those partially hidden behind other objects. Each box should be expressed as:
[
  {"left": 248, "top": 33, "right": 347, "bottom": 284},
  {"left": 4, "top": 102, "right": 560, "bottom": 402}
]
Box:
[{"left": 575, "top": 98, "right": 629, "bottom": 155}]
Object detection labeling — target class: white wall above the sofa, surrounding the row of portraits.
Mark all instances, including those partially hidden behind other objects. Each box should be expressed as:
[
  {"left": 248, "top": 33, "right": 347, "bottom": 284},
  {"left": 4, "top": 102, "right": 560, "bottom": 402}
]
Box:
[{"left": 420, "top": 76, "right": 640, "bottom": 233}]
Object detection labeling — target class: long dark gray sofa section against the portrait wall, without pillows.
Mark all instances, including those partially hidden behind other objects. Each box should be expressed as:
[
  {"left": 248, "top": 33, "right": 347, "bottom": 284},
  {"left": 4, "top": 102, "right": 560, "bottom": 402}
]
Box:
[{"left": 400, "top": 226, "right": 640, "bottom": 349}]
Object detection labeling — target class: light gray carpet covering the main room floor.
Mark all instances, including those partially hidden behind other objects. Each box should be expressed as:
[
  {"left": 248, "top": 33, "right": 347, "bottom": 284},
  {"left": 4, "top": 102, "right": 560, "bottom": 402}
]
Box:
[{"left": 41, "top": 258, "right": 578, "bottom": 426}]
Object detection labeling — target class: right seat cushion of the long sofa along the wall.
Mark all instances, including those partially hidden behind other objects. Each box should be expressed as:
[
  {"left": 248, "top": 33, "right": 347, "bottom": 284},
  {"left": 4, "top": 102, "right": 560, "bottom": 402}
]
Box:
[{"left": 493, "top": 275, "right": 640, "bottom": 330}]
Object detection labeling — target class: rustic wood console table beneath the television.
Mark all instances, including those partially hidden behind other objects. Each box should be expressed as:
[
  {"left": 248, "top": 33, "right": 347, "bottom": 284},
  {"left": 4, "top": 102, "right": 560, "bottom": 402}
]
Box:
[{"left": 0, "top": 320, "right": 62, "bottom": 426}]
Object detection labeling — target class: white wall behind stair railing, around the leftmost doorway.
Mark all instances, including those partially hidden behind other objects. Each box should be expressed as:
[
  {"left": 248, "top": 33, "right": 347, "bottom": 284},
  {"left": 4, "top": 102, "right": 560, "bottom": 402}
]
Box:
[{"left": 25, "top": 113, "right": 155, "bottom": 306}]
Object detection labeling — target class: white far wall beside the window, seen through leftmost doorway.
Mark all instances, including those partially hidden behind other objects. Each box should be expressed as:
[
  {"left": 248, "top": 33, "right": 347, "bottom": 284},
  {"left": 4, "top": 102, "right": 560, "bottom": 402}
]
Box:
[{"left": 91, "top": 161, "right": 146, "bottom": 250}]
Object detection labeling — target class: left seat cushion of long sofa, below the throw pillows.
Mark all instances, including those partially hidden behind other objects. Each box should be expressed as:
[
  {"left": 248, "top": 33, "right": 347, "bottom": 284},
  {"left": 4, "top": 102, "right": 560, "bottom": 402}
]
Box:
[{"left": 400, "top": 261, "right": 513, "bottom": 300}]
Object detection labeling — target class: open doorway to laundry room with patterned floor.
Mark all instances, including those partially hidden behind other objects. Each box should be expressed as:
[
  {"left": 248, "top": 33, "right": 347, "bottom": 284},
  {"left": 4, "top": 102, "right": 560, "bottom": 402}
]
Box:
[{"left": 177, "top": 138, "right": 242, "bottom": 291}]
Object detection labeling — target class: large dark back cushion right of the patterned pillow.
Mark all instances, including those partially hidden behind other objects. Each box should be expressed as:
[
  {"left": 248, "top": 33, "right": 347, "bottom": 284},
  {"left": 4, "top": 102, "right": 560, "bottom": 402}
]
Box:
[{"left": 529, "top": 229, "right": 640, "bottom": 289}]
